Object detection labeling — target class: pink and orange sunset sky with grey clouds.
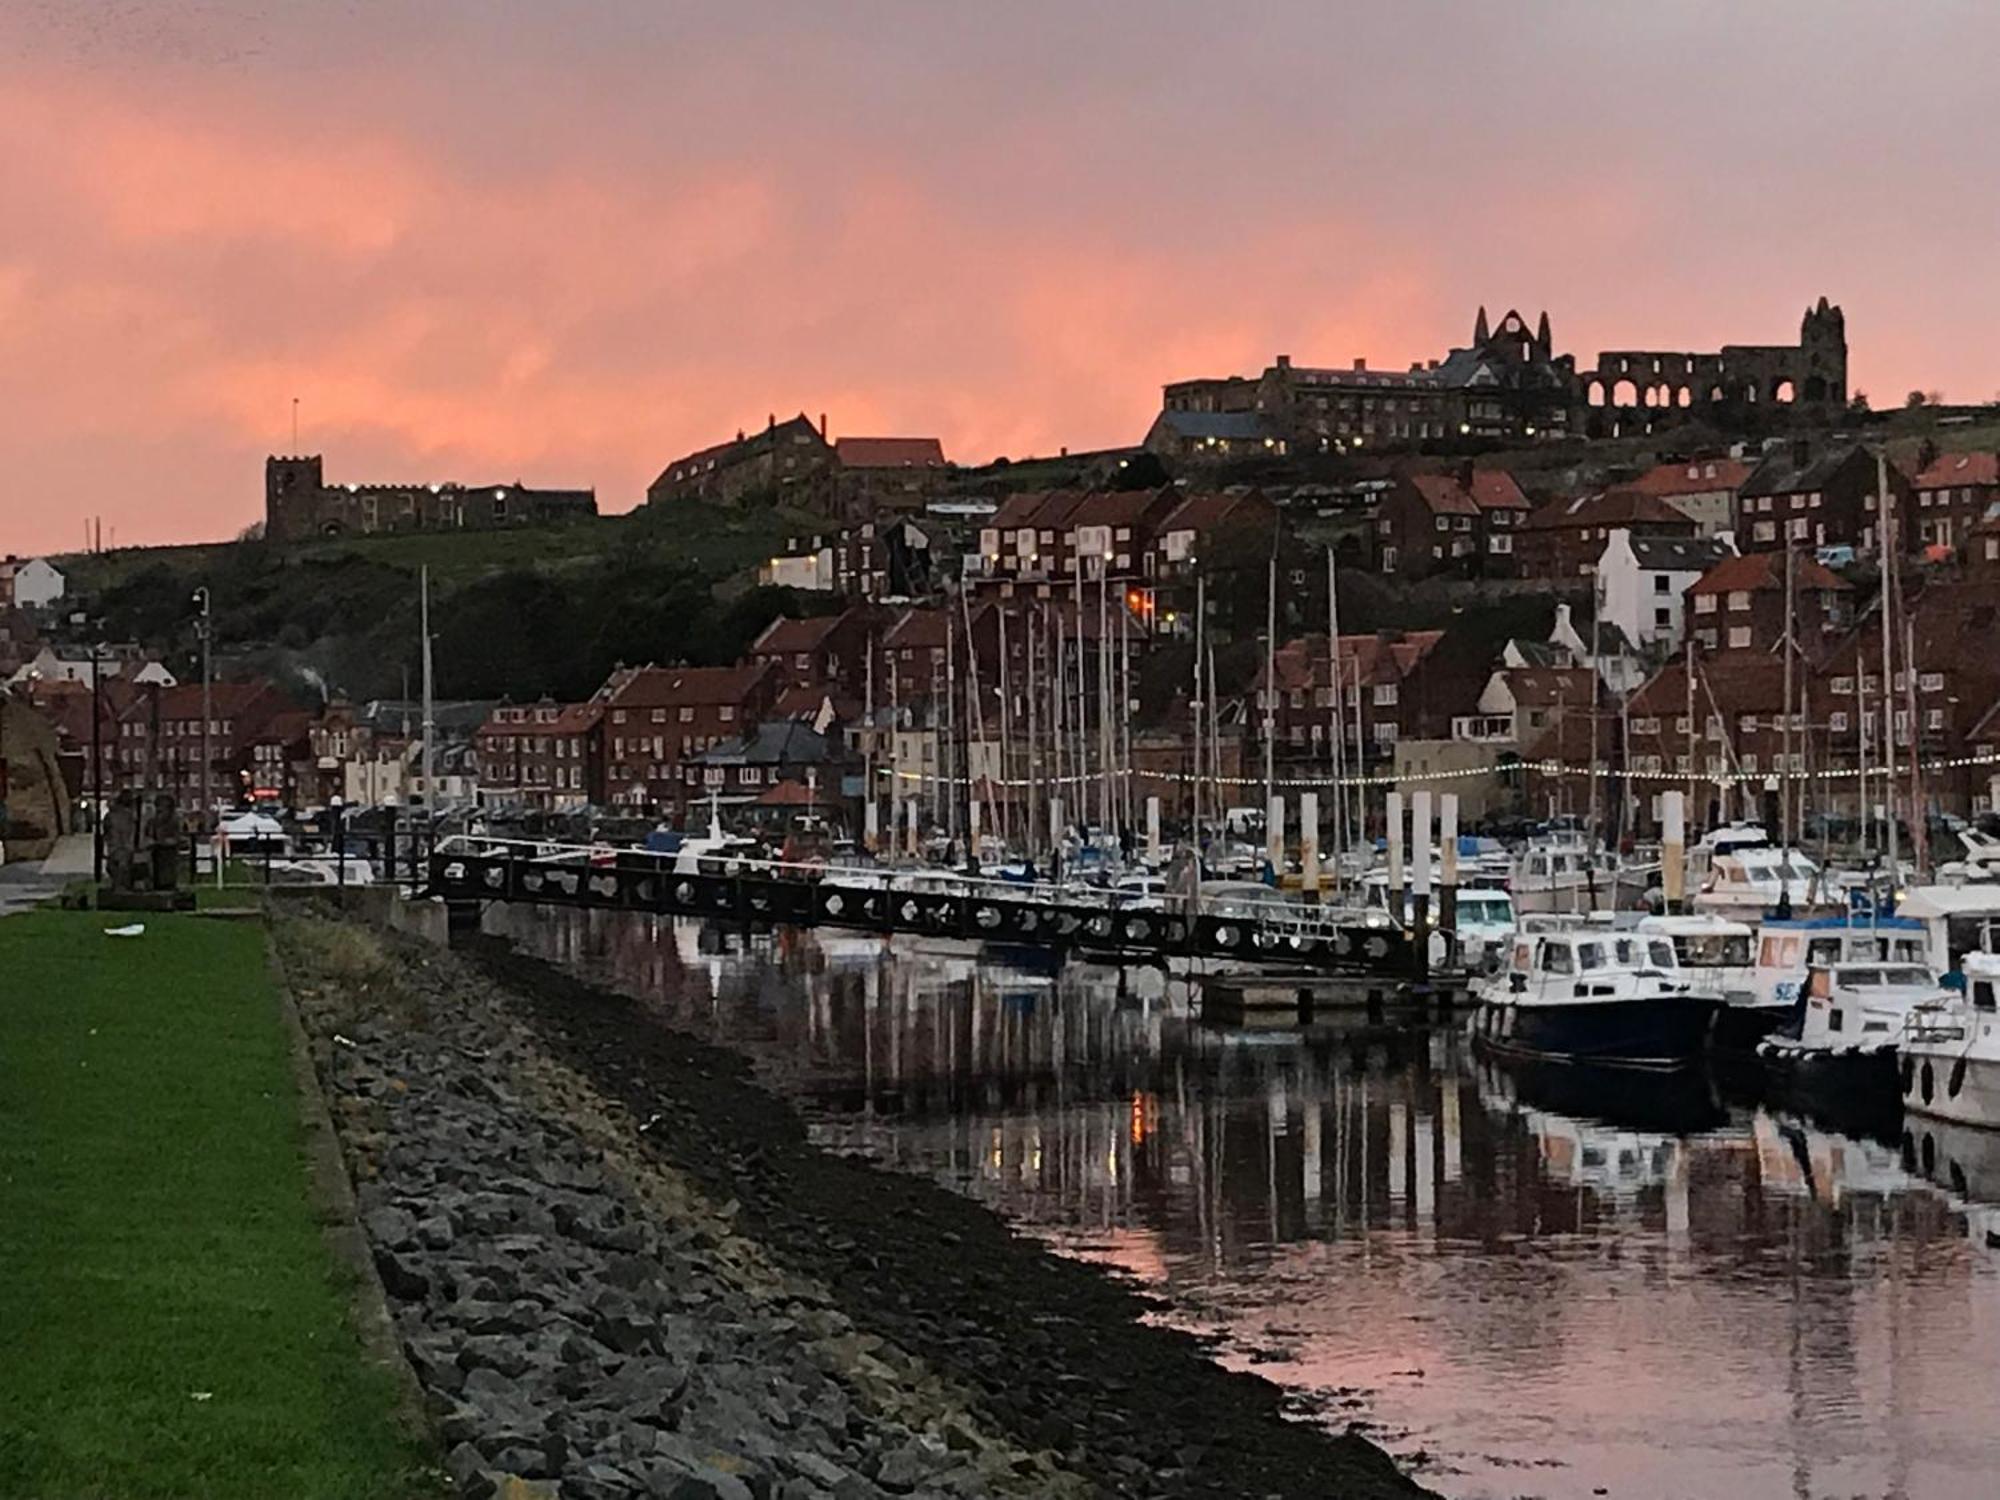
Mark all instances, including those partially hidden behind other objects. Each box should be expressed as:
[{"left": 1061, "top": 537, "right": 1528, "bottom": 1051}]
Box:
[{"left": 0, "top": 0, "right": 2000, "bottom": 554}]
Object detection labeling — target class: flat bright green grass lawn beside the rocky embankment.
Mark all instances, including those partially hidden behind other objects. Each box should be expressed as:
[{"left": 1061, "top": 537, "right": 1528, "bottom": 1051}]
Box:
[{"left": 0, "top": 910, "right": 424, "bottom": 1500}]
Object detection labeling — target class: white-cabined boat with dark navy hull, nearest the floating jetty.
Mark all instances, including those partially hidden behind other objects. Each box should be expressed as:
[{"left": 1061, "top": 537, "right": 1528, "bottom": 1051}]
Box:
[{"left": 1472, "top": 926, "right": 1722, "bottom": 1070}]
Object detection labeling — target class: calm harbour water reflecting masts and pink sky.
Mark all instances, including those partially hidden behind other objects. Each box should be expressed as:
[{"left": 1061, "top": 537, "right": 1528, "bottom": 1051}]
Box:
[{"left": 488, "top": 910, "right": 2000, "bottom": 1500}]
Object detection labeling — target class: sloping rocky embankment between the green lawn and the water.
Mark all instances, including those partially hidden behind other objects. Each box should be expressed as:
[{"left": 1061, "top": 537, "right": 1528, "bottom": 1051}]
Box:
[{"left": 278, "top": 918, "right": 1424, "bottom": 1500}]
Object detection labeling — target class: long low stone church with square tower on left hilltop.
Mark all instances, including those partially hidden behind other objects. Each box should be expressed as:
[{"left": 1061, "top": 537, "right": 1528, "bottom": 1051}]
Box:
[{"left": 264, "top": 454, "right": 598, "bottom": 542}]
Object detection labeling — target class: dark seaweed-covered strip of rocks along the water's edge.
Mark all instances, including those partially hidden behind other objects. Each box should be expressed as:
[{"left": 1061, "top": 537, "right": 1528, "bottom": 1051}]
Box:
[{"left": 446, "top": 938, "right": 1426, "bottom": 1500}]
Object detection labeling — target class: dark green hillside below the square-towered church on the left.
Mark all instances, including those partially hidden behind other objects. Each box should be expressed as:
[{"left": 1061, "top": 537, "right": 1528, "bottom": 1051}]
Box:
[{"left": 60, "top": 494, "right": 824, "bottom": 698}]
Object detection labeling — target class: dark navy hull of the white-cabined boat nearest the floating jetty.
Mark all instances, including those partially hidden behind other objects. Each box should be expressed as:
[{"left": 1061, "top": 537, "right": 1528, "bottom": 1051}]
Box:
[{"left": 1472, "top": 994, "right": 1720, "bottom": 1070}]
